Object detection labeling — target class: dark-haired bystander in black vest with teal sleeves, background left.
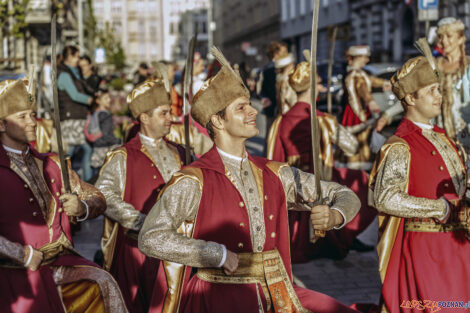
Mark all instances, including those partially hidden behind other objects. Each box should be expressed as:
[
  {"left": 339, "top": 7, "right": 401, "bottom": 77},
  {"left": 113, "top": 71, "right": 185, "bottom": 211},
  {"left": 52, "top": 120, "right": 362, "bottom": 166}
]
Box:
[{"left": 57, "top": 46, "right": 93, "bottom": 181}]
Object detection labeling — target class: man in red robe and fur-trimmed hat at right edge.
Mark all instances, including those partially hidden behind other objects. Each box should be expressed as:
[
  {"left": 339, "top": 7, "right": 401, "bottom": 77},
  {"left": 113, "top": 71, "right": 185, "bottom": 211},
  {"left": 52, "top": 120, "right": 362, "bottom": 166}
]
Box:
[{"left": 370, "top": 56, "right": 470, "bottom": 313}]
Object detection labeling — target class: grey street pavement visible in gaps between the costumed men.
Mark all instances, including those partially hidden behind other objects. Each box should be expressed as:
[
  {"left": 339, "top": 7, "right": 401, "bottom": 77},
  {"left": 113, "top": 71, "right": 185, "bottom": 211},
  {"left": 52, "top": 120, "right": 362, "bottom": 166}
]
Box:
[{"left": 74, "top": 102, "right": 381, "bottom": 305}]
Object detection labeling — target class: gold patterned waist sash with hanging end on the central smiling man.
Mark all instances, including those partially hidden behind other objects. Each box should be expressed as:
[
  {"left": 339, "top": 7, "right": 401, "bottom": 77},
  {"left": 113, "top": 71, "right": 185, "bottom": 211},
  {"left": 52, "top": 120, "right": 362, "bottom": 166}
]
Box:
[{"left": 197, "top": 250, "right": 310, "bottom": 313}]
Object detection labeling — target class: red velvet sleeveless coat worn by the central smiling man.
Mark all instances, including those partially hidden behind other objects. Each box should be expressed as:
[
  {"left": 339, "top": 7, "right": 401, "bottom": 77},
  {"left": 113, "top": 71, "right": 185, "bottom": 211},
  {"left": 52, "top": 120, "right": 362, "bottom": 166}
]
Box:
[{"left": 150, "top": 146, "right": 357, "bottom": 313}]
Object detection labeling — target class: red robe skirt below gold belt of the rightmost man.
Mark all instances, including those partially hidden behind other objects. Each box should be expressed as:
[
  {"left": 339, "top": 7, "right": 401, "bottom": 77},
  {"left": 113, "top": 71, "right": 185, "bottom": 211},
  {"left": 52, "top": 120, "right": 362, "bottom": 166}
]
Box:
[{"left": 392, "top": 230, "right": 470, "bottom": 313}]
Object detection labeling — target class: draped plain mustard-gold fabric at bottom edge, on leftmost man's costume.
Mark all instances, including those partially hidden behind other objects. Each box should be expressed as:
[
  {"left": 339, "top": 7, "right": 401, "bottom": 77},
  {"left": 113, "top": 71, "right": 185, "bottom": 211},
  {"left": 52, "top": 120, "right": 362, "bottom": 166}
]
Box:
[{"left": 61, "top": 280, "right": 106, "bottom": 313}]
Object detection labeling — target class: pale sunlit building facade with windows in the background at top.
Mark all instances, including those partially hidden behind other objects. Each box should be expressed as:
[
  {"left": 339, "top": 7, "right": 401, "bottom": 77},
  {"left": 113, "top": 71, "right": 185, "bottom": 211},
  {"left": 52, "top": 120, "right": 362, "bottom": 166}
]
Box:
[{"left": 93, "top": 0, "right": 208, "bottom": 65}]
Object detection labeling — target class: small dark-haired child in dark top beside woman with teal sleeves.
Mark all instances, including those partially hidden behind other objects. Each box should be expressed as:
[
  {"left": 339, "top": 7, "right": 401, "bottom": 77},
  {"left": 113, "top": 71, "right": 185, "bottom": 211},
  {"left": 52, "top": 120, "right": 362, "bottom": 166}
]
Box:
[{"left": 91, "top": 90, "right": 121, "bottom": 174}]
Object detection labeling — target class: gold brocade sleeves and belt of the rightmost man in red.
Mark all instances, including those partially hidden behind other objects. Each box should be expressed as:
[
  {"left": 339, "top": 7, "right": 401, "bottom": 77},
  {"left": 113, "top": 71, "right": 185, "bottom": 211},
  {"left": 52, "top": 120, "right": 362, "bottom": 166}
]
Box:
[{"left": 369, "top": 130, "right": 468, "bottom": 281}]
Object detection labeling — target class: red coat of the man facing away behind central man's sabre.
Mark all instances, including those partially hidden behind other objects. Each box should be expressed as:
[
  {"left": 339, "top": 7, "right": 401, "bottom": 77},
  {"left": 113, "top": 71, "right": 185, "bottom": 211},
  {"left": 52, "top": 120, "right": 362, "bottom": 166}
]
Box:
[{"left": 273, "top": 102, "right": 377, "bottom": 263}]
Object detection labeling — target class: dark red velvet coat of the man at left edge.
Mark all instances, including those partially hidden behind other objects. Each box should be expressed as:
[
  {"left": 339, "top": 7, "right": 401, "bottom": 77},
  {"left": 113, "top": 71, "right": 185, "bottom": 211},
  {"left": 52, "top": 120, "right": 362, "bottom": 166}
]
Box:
[{"left": 0, "top": 144, "right": 96, "bottom": 313}]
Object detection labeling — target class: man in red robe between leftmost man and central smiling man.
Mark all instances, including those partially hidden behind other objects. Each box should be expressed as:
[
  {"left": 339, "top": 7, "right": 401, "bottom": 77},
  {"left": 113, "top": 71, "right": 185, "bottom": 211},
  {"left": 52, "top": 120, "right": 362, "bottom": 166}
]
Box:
[{"left": 96, "top": 78, "right": 185, "bottom": 313}]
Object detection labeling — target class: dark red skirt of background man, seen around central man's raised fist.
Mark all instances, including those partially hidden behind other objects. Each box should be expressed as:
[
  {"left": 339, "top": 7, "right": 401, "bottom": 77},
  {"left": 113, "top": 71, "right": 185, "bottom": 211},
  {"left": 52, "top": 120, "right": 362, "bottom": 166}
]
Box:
[{"left": 289, "top": 168, "right": 377, "bottom": 263}]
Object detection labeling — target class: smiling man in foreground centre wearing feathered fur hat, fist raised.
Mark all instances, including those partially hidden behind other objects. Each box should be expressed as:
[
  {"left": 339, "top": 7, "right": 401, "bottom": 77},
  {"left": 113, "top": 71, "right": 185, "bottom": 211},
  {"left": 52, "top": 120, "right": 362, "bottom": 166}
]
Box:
[{"left": 139, "top": 48, "right": 360, "bottom": 313}]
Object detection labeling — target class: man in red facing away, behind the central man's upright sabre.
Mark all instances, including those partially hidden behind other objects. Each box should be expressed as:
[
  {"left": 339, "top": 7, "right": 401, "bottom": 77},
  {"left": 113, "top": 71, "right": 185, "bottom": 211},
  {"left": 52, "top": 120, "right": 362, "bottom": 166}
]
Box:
[{"left": 268, "top": 62, "right": 377, "bottom": 263}]
